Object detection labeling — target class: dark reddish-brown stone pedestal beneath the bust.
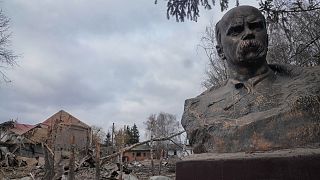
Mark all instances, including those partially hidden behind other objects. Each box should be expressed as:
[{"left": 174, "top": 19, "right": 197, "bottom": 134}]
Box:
[{"left": 176, "top": 148, "right": 320, "bottom": 180}]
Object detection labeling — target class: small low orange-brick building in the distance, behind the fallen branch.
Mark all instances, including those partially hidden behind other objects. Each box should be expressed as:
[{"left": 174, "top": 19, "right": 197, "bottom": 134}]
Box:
[{"left": 122, "top": 144, "right": 151, "bottom": 162}]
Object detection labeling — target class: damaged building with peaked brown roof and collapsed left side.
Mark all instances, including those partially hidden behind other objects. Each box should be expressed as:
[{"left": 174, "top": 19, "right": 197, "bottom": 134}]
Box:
[{"left": 0, "top": 110, "right": 92, "bottom": 160}]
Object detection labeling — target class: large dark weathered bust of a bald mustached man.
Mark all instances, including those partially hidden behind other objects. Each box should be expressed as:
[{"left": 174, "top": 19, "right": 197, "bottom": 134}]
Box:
[{"left": 182, "top": 6, "right": 320, "bottom": 153}]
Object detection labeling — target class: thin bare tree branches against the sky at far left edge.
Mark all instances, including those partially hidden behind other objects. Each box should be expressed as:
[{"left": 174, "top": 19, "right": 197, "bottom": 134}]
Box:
[{"left": 0, "top": 10, "right": 18, "bottom": 82}]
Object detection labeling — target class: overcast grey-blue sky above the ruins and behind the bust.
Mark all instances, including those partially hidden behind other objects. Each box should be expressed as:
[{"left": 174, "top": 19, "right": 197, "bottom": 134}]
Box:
[{"left": 0, "top": 0, "right": 257, "bottom": 139}]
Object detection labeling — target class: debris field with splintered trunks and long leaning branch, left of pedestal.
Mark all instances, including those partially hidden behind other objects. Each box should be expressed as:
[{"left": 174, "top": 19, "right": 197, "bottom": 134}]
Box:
[{"left": 0, "top": 121, "right": 183, "bottom": 180}]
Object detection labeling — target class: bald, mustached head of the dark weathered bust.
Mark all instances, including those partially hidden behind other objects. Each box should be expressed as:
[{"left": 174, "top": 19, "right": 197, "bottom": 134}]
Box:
[{"left": 220, "top": 6, "right": 268, "bottom": 66}]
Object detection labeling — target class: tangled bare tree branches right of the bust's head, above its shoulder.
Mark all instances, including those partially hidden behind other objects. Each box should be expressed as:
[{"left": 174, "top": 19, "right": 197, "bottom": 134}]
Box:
[{"left": 261, "top": 0, "right": 320, "bottom": 66}]
